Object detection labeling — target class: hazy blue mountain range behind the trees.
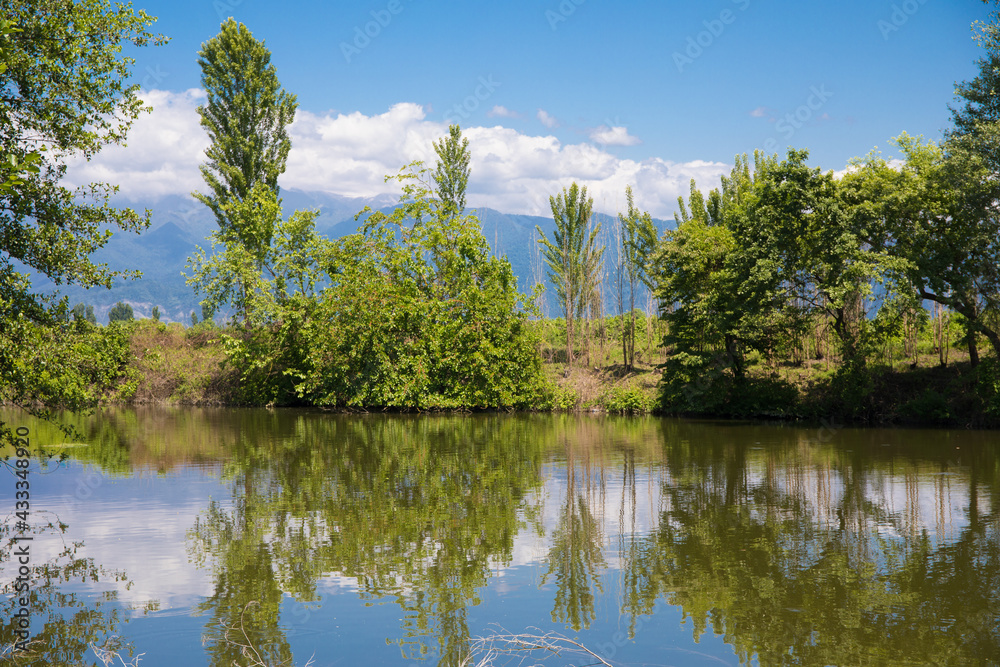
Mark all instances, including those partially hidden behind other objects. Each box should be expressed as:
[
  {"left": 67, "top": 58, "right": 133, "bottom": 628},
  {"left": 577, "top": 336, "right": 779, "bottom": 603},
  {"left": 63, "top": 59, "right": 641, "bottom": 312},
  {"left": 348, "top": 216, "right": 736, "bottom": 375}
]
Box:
[{"left": 35, "top": 190, "right": 672, "bottom": 323}]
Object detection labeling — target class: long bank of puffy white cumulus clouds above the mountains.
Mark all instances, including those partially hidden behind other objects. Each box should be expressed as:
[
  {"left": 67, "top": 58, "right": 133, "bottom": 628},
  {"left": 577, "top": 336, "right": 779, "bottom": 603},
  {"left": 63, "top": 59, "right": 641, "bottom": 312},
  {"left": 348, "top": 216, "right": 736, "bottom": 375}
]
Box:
[{"left": 70, "top": 91, "right": 731, "bottom": 218}]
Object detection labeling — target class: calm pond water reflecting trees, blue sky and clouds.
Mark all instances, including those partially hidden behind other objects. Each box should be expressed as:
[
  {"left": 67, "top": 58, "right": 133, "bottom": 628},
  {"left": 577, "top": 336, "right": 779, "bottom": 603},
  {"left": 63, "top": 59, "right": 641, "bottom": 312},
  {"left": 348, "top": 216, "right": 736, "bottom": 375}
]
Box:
[{"left": 0, "top": 409, "right": 1000, "bottom": 667}]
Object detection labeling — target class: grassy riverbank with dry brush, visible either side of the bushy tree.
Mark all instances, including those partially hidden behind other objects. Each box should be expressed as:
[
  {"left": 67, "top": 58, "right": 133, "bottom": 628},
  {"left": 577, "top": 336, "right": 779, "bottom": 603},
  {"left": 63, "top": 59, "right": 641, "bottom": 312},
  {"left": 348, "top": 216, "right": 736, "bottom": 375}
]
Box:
[{"left": 116, "top": 320, "right": 1000, "bottom": 428}]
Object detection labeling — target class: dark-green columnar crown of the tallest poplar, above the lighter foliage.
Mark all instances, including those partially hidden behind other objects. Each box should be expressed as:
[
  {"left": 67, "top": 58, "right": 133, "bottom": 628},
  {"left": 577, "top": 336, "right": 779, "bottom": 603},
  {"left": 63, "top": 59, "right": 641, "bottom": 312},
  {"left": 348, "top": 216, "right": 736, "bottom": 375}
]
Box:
[{"left": 194, "top": 18, "right": 298, "bottom": 253}]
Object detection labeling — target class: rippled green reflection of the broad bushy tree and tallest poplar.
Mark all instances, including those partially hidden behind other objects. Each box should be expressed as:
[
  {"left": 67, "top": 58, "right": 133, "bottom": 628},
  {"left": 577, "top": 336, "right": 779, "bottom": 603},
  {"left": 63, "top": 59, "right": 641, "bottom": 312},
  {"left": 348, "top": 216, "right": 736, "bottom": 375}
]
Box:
[{"left": 190, "top": 416, "right": 541, "bottom": 666}]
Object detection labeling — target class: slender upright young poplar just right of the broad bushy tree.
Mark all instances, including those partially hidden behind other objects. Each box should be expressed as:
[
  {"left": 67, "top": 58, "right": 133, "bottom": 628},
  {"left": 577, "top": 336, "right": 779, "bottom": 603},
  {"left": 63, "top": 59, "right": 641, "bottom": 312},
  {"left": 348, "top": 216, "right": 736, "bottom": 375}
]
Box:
[{"left": 535, "top": 182, "right": 604, "bottom": 366}]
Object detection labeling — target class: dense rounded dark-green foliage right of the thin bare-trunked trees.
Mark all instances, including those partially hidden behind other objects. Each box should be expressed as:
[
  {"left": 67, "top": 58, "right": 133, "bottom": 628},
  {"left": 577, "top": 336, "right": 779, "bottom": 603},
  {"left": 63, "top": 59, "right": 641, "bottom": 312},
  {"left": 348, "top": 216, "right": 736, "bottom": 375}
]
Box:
[{"left": 656, "top": 150, "right": 911, "bottom": 409}]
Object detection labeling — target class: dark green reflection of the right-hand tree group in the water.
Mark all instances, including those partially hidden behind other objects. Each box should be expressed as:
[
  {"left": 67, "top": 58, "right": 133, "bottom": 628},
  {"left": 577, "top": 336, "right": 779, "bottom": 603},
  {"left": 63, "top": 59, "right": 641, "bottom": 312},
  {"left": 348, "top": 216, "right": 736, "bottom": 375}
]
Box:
[{"left": 621, "top": 422, "right": 1000, "bottom": 665}]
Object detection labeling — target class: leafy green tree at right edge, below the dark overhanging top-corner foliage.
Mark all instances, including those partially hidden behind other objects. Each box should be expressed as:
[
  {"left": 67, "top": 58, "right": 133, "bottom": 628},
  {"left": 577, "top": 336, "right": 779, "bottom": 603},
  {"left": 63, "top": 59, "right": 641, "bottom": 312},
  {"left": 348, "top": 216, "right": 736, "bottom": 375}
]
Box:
[{"left": 845, "top": 134, "right": 1000, "bottom": 366}]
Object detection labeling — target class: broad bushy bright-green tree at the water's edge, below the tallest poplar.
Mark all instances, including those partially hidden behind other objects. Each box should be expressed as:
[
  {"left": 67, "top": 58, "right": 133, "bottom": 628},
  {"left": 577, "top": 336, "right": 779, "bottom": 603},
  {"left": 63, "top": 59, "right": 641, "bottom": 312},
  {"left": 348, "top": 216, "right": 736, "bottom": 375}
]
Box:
[{"left": 297, "top": 165, "right": 542, "bottom": 408}]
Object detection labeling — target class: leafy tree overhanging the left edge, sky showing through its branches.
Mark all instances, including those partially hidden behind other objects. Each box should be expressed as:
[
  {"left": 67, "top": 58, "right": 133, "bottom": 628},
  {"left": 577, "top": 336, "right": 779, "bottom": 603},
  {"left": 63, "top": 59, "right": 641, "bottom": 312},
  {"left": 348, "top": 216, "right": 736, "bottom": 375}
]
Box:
[{"left": 0, "top": 0, "right": 163, "bottom": 440}]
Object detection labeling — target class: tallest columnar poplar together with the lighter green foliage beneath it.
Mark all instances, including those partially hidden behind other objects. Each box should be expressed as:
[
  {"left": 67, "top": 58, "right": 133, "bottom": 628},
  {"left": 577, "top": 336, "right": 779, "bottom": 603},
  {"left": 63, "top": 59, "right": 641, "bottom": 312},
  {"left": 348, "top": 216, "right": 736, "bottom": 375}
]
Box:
[{"left": 188, "top": 18, "right": 298, "bottom": 326}]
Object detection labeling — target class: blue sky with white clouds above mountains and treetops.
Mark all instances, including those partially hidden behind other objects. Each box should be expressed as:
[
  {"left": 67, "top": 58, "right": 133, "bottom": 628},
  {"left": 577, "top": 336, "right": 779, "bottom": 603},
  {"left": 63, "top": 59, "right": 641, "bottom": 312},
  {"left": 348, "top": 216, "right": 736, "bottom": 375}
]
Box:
[{"left": 69, "top": 0, "right": 989, "bottom": 219}]
